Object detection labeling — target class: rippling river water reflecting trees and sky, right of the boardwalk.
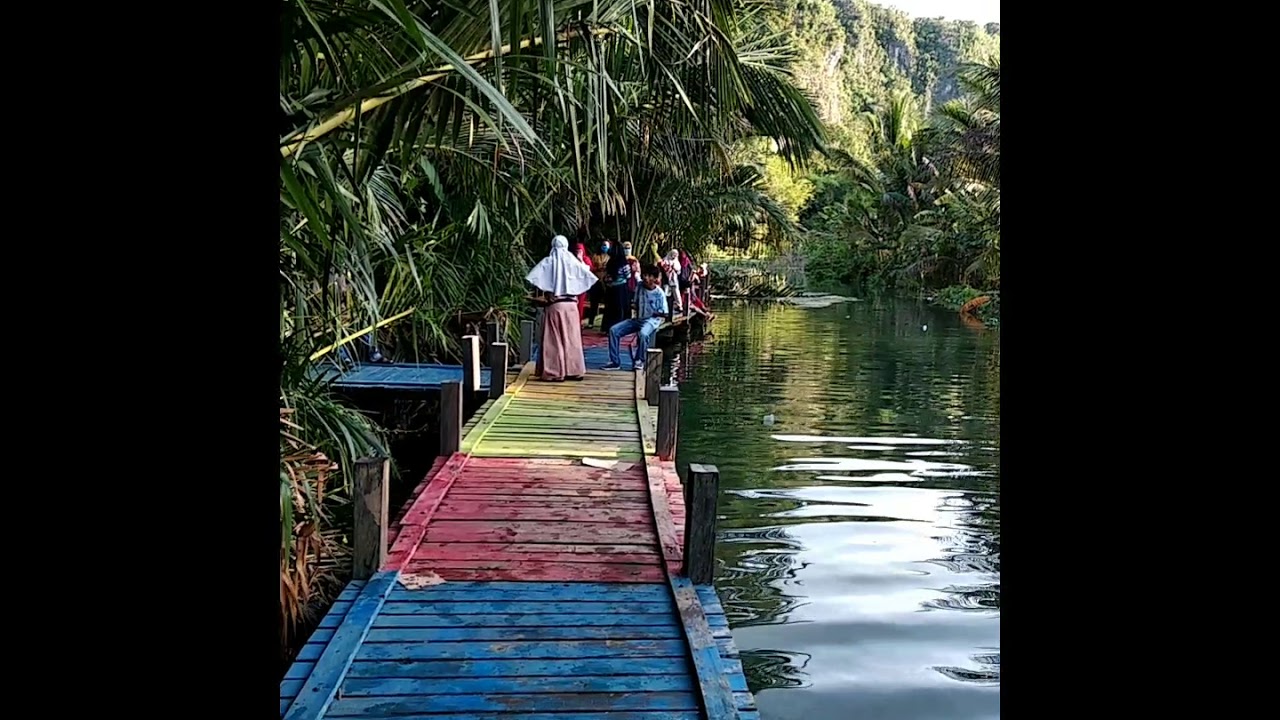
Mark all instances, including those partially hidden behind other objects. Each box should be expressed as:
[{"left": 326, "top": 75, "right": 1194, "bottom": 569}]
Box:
[{"left": 676, "top": 300, "right": 1000, "bottom": 720}]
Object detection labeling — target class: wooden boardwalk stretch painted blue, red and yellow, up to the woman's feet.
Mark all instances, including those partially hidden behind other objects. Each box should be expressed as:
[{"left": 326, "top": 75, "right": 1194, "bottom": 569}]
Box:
[{"left": 280, "top": 327, "right": 759, "bottom": 720}]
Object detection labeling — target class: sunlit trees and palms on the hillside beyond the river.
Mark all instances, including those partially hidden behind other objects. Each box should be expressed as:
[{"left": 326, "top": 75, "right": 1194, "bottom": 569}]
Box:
[{"left": 747, "top": 0, "right": 1000, "bottom": 297}]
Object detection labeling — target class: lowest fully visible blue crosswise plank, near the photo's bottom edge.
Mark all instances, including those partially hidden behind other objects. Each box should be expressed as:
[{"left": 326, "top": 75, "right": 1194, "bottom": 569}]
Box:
[{"left": 325, "top": 692, "right": 698, "bottom": 717}]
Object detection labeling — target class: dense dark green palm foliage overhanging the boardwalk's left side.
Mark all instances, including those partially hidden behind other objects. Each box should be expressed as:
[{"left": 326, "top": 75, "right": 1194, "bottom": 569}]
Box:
[{"left": 279, "top": 0, "right": 826, "bottom": 666}]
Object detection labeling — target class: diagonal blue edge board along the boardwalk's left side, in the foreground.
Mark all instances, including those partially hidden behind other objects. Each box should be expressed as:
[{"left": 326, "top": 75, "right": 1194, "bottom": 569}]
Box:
[{"left": 284, "top": 571, "right": 399, "bottom": 720}]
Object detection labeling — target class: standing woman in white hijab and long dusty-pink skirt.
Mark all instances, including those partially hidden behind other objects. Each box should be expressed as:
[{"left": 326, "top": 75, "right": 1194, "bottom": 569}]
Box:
[{"left": 525, "top": 234, "right": 596, "bottom": 383}]
